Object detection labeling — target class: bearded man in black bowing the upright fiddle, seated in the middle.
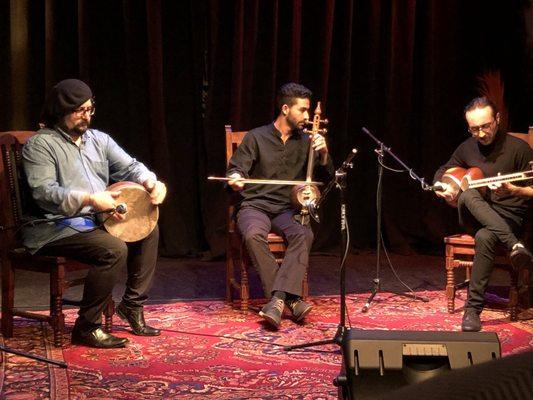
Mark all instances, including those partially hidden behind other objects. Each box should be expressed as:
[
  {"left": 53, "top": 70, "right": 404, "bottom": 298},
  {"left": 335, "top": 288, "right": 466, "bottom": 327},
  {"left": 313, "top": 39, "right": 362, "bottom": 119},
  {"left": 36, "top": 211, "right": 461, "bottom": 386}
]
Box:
[{"left": 226, "top": 83, "right": 333, "bottom": 328}]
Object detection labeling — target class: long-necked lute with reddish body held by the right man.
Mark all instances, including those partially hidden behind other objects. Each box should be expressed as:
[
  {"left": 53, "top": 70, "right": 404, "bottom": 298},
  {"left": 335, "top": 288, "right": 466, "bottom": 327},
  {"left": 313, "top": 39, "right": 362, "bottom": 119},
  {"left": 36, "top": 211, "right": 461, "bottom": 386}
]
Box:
[{"left": 442, "top": 164, "right": 533, "bottom": 206}]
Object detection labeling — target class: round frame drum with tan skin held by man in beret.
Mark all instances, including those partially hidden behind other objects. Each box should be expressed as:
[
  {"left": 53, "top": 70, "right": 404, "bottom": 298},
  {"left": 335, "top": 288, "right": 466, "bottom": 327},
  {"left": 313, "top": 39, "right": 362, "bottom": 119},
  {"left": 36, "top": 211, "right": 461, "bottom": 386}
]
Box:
[{"left": 103, "top": 181, "right": 159, "bottom": 242}]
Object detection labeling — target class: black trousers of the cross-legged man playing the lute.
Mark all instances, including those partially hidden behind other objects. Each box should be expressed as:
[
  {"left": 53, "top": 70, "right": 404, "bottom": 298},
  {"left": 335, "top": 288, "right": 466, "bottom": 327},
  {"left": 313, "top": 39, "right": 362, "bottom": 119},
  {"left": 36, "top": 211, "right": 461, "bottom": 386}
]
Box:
[{"left": 457, "top": 189, "right": 523, "bottom": 312}]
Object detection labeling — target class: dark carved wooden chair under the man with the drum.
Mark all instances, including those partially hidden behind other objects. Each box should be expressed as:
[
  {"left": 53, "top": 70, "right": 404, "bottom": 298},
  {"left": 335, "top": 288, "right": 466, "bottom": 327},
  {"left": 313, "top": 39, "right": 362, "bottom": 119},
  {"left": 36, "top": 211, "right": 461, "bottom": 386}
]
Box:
[{"left": 0, "top": 132, "right": 114, "bottom": 347}]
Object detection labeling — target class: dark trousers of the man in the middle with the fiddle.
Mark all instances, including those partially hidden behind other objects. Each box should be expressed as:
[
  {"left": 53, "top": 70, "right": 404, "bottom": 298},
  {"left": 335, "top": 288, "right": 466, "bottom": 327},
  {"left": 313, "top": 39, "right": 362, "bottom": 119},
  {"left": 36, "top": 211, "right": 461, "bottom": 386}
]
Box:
[{"left": 237, "top": 207, "right": 313, "bottom": 296}]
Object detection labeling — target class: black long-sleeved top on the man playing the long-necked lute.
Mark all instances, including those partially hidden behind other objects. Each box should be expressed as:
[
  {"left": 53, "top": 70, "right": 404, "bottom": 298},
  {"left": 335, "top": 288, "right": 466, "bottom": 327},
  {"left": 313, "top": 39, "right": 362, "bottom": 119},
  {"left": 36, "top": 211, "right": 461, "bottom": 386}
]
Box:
[{"left": 434, "top": 132, "right": 533, "bottom": 215}]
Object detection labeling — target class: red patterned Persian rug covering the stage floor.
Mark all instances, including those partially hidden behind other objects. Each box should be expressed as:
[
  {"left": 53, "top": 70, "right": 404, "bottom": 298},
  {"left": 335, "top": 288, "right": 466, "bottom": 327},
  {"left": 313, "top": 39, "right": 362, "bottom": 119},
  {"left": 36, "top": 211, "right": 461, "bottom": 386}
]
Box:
[{"left": 0, "top": 291, "right": 533, "bottom": 400}]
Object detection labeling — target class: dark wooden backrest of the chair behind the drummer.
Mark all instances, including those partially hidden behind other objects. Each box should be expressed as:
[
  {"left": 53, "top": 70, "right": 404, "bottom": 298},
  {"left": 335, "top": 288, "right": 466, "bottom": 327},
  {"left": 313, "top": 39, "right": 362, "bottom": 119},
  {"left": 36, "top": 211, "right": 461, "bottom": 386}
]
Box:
[{"left": 0, "top": 131, "right": 35, "bottom": 256}]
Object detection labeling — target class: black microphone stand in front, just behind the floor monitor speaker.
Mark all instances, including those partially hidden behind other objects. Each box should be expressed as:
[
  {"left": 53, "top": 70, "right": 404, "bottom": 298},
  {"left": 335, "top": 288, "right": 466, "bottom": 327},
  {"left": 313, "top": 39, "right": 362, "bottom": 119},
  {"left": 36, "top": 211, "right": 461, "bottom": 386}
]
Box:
[{"left": 283, "top": 149, "right": 357, "bottom": 351}]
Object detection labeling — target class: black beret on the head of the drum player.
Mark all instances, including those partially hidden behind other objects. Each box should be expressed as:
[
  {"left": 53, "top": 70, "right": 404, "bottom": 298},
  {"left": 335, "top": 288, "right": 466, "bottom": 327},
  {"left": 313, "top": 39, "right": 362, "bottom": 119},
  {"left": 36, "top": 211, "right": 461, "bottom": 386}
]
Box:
[{"left": 41, "top": 79, "right": 93, "bottom": 127}]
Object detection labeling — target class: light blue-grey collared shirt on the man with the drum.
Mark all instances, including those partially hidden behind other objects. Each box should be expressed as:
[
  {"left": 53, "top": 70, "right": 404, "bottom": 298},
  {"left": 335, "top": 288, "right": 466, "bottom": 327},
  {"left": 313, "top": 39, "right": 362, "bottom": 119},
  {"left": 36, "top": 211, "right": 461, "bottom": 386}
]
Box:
[{"left": 22, "top": 127, "right": 156, "bottom": 253}]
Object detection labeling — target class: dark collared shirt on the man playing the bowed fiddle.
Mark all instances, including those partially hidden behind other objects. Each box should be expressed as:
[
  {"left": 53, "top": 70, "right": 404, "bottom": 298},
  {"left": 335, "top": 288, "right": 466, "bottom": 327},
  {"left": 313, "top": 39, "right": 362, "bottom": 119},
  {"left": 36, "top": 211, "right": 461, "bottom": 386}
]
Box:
[{"left": 226, "top": 123, "right": 333, "bottom": 214}]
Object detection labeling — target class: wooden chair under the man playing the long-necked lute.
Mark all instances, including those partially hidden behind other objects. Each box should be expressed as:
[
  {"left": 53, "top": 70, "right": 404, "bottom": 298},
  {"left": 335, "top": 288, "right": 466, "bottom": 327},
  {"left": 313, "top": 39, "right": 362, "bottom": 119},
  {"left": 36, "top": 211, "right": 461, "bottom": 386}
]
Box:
[{"left": 444, "top": 126, "right": 533, "bottom": 321}]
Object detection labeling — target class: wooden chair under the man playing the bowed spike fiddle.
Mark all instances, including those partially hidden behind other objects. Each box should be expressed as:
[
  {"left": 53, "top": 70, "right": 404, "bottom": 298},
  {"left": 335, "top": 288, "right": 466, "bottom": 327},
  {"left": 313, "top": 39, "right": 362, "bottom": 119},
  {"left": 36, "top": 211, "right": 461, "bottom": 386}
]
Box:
[{"left": 225, "top": 125, "right": 309, "bottom": 312}]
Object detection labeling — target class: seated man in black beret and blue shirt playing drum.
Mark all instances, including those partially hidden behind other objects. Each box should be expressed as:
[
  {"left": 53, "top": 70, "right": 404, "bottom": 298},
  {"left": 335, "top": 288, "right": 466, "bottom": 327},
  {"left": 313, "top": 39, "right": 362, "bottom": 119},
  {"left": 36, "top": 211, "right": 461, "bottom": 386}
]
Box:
[{"left": 22, "top": 79, "right": 166, "bottom": 348}]
